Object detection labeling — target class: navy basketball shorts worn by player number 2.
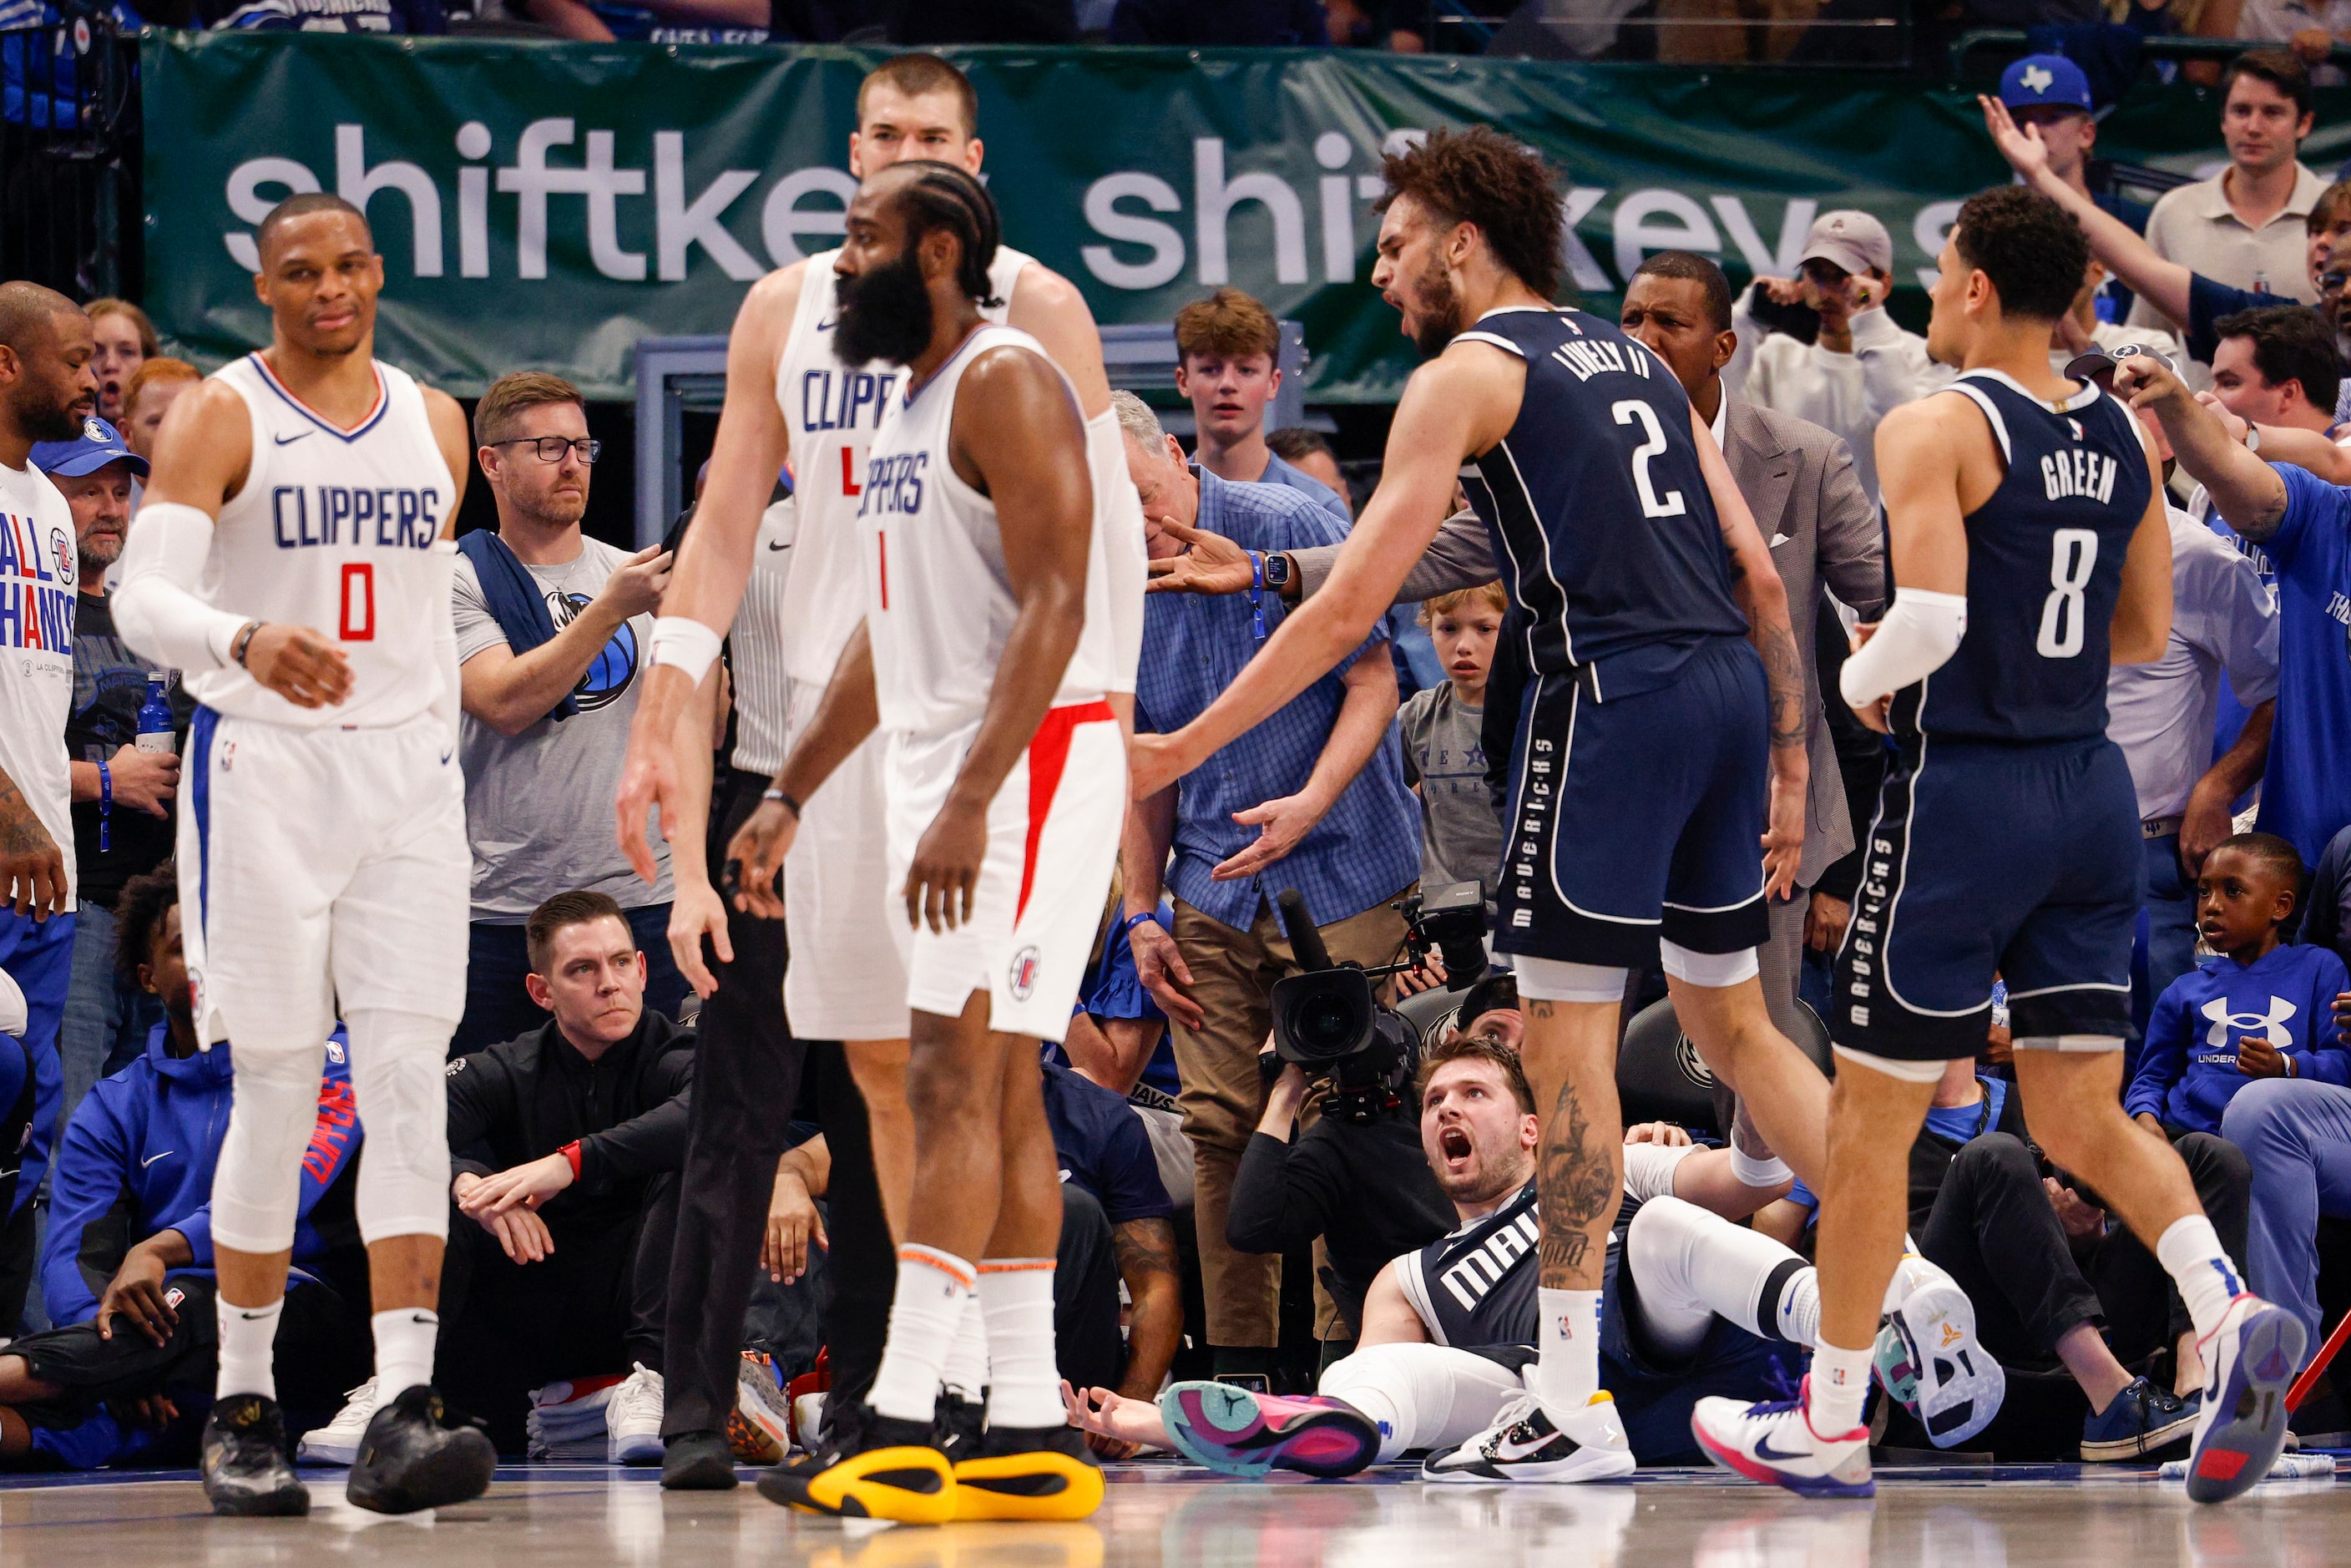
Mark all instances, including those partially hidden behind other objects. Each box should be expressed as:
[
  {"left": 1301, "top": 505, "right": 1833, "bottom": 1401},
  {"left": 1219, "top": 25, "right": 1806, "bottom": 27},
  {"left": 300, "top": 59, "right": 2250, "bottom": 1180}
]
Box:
[{"left": 1495, "top": 637, "right": 1770, "bottom": 969}]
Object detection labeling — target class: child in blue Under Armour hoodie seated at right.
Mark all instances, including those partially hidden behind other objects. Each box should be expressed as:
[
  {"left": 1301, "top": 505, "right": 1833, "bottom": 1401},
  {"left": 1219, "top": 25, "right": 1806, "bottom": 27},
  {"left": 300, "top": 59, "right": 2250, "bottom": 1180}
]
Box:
[{"left": 2123, "top": 832, "right": 2351, "bottom": 1138}]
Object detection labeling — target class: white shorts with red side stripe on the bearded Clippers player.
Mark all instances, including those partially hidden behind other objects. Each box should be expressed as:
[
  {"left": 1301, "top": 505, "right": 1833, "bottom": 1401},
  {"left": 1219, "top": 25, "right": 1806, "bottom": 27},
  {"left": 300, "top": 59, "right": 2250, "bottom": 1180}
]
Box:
[{"left": 888, "top": 703, "right": 1126, "bottom": 1041}]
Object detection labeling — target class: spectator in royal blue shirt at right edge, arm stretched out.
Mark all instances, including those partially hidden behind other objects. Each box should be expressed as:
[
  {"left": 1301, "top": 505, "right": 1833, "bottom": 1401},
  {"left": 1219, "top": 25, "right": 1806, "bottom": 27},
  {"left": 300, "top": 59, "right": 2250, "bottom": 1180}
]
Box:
[{"left": 2116, "top": 355, "right": 2351, "bottom": 862}]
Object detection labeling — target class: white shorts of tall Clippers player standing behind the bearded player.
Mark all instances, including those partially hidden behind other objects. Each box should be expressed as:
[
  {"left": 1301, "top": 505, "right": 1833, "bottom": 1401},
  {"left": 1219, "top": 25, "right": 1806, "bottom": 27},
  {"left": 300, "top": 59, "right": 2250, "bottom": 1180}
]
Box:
[{"left": 783, "top": 682, "right": 905, "bottom": 1039}]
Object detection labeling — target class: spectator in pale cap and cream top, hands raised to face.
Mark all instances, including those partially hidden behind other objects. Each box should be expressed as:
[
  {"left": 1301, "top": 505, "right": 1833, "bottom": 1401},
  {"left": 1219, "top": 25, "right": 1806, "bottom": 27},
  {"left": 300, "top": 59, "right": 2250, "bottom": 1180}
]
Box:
[{"left": 1723, "top": 210, "right": 1951, "bottom": 501}]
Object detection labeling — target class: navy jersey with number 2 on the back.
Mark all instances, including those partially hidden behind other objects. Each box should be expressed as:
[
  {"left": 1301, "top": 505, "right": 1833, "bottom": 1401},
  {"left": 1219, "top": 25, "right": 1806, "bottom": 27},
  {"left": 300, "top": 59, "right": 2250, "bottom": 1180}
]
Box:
[{"left": 1455, "top": 306, "right": 1747, "bottom": 701}]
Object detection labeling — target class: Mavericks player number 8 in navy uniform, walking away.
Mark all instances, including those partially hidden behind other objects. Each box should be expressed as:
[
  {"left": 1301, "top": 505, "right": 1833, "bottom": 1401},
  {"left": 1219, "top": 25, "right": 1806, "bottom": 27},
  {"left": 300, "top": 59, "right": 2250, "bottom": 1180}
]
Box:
[{"left": 1691, "top": 185, "right": 2304, "bottom": 1502}]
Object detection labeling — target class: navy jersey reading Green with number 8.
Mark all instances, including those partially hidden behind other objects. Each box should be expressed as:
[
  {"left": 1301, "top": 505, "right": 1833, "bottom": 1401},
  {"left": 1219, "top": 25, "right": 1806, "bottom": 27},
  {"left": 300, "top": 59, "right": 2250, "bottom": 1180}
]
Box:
[{"left": 1893, "top": 372, "right": 2153, "bottom": 743}]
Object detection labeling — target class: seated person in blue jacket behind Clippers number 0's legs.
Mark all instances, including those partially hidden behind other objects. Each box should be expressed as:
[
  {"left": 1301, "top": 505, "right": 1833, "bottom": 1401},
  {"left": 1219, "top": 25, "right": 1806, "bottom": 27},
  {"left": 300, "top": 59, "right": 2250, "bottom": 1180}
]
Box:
[{"left": 0, "top": 862, "right": 367, "bottom": 1469}]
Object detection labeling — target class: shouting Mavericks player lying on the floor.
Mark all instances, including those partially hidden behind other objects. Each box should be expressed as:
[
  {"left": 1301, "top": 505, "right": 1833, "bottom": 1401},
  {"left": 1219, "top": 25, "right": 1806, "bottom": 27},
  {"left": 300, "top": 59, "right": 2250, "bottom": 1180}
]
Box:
[{"left": 1065, "top": 1037, "right": 2003, "bottom": 1484}]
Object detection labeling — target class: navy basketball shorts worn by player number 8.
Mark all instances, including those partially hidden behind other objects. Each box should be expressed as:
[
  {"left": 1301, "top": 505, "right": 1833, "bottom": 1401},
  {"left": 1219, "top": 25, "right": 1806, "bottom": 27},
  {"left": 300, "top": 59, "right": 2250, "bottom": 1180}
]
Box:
[{"left": 1829, "top": 736, "right": 2141, "bottom": 1063}]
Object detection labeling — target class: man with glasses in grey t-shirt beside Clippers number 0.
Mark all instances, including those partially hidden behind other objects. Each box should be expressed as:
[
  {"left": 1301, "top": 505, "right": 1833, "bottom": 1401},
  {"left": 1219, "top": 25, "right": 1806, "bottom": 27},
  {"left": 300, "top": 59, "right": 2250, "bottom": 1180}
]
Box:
[{"left": 449, "top": 372, "right": 684, "bottom": 1055}]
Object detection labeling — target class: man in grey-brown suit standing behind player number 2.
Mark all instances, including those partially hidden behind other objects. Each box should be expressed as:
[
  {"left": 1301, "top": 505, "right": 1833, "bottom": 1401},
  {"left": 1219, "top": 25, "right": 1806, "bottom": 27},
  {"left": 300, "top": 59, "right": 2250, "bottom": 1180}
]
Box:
[{"left": 1155, "top": 251, "right": 1885, "bottom": 1062}]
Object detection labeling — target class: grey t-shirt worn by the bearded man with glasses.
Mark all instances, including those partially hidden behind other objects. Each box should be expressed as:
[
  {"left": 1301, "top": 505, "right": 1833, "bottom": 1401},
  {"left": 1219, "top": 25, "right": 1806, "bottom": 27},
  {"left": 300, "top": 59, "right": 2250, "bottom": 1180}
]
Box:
[{"left": 456, "top": 536, "right": 675, "bottom": 926}]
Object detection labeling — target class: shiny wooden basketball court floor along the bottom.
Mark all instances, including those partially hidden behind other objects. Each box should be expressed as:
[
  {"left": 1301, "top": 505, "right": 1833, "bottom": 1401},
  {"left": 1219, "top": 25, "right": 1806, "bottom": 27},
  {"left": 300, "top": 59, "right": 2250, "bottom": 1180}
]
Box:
[{"left": 0, "top": 1462, "right": 2351, "bottom": 1568}]
